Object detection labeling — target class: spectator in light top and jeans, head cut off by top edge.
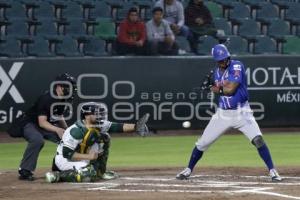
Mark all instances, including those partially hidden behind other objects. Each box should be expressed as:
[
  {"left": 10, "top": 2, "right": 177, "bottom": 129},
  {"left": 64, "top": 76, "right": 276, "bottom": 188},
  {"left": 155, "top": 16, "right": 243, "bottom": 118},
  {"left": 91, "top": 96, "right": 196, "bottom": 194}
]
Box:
[{"left": 155, "top": 0, "right": 190, "bottom": 38}]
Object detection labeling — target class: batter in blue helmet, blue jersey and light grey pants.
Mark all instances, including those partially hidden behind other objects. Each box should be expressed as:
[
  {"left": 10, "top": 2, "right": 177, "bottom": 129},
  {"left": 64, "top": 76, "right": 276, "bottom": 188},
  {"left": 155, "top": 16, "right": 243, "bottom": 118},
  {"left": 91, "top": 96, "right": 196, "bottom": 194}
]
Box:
[{"left": 176, "top": 44, "right": 282, "bottom": 181}]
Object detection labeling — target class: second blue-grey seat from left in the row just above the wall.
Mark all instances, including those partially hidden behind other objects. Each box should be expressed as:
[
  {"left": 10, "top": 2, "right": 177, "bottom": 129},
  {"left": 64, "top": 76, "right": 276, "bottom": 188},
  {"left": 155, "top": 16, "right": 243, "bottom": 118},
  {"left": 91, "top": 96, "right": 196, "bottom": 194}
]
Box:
[{"left": 27, "top": 36, "right": 55, "bottom": 57}]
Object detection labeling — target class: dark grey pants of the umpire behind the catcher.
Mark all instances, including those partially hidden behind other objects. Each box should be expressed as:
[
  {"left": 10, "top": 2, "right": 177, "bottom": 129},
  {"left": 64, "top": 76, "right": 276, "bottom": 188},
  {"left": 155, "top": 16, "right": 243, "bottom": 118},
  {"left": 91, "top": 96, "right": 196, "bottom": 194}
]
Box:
[{"left": 20, "top": 123, "right": 60, "bottom": 171}]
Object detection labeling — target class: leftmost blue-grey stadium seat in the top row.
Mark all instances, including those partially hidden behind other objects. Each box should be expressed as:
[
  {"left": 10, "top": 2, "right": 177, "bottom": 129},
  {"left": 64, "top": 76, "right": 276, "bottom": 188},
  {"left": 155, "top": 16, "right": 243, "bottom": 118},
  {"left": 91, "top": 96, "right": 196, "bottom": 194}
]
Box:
[{"left": 5, "top": 1, "right": 27, "bottom": 20}]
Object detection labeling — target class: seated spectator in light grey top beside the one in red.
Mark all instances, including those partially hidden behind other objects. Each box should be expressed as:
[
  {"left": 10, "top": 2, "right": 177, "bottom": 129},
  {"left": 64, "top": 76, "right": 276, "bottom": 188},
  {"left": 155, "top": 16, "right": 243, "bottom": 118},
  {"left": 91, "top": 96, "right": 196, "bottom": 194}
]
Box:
[{"left": 146, "top": 7, "right": 178, "bottom": 55}]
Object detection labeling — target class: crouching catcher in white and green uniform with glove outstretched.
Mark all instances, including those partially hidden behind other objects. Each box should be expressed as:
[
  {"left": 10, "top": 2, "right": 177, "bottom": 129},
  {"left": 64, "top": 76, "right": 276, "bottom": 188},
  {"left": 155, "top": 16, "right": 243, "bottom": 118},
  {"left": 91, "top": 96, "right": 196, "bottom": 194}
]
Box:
[{"left": 46, "top": 102, "right": 149, "bottom": 183}]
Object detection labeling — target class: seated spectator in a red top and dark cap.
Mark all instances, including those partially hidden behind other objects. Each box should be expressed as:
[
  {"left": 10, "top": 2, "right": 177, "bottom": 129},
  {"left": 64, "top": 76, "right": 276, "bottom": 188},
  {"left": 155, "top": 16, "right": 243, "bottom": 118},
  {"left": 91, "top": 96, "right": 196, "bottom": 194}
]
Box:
[{"left": 116, "top": 7, "right": 146, "bottom": 55}]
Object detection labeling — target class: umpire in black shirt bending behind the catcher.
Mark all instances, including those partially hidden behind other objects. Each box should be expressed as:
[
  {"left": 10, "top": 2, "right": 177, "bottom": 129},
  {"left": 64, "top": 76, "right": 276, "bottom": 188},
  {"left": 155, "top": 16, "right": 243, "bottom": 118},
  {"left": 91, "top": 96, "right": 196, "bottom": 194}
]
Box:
[{"left": 8, "top": 73, "right": 76, "bottom": 181}]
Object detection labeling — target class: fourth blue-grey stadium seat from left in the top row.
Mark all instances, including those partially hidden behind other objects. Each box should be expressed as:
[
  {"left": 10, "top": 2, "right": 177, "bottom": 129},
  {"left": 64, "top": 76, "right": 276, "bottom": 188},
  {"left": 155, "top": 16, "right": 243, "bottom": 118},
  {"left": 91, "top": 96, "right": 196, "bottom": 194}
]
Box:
[{"left": 89, "top": 1, "right": 111, "bottom": 20}]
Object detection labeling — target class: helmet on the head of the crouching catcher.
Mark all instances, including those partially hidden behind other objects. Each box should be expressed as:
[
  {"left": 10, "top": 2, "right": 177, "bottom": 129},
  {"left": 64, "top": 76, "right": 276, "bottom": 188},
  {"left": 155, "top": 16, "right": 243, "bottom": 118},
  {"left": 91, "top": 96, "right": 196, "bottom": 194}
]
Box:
[{"left": 80, "top": 102, "right": 107, "bottom": 123}]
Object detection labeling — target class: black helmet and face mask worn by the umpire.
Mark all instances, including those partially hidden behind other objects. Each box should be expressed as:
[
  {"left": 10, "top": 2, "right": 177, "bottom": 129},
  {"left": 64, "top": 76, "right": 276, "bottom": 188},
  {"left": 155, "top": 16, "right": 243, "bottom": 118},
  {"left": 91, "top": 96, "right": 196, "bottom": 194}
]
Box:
[{"left": 55, "top": 73, "right": 77, "bottom": 100}]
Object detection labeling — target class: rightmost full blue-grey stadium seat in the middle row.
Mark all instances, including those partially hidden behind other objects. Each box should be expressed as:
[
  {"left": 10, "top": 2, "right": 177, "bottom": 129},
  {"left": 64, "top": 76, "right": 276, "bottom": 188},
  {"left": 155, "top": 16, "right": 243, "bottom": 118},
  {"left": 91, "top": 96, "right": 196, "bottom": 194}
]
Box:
[{"left": 268, "top": 19, "right": 290, "bottom": 40}]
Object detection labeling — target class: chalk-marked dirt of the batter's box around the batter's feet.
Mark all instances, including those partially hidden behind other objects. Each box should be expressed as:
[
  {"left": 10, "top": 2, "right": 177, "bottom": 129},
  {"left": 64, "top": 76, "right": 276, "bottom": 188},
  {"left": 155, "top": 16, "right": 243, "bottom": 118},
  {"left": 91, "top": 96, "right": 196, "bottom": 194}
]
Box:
[{"left": 81, "top": 175, "right": 300, "bottom": 200}]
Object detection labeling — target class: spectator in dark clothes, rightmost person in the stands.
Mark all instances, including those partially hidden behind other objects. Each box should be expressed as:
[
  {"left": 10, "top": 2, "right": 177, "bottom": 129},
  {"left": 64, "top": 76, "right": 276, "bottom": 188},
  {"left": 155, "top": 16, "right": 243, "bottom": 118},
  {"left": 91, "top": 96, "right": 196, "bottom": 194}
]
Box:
[{"left": 184, "top": 0, "right": 217, "bottom": 51}]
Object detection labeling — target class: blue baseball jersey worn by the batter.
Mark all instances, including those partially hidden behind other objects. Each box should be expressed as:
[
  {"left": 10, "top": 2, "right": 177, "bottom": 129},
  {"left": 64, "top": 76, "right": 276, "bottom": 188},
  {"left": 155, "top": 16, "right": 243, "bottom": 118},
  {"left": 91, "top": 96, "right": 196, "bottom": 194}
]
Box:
[{"left": 214, "top": 60, "right": 249, "bottom": 110}]
